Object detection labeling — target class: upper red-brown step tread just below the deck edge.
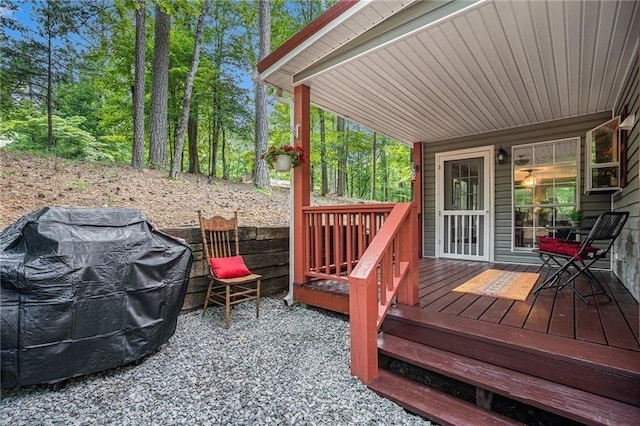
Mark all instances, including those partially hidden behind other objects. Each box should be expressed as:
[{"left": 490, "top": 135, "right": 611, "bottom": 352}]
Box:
[{"left": 378, "top": 333, "right": 640, "bottom": 424}]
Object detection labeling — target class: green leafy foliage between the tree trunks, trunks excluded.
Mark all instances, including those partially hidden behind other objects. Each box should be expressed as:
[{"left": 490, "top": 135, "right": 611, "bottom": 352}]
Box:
[{"left": 0, "top": 0, "right": 412, "bottom": 201}]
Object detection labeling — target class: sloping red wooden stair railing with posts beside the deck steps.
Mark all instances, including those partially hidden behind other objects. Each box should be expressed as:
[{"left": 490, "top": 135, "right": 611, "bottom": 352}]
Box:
[{"left": 349, "top": 203, "right": 418, "bottom": 383}]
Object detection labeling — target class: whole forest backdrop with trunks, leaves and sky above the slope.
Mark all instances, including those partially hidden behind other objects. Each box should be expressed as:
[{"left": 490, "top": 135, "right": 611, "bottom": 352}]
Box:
[{"left": 0, "top": 0, "right": 412, "bottom": 201}]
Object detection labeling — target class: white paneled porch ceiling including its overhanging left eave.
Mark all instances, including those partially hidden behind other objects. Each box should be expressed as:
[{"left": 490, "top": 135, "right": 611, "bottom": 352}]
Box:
[{"left": 258, "top": 0, "right": 640, "bottom": 145}]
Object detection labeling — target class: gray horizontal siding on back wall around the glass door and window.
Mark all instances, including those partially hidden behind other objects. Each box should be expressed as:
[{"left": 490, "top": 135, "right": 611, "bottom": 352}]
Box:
[{"left": 422, "top": 111, "right": 611, "bottom": 267}]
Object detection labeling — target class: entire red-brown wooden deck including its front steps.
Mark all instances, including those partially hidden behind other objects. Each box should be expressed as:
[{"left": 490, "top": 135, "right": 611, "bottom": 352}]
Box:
[{"left": 296, "top": 259, "right": 640, "bottom": 424}]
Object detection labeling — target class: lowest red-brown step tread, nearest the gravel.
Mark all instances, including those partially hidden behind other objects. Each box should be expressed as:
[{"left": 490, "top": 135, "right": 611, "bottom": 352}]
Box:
[{"left": 368, "top": 370, "right": 521, "bottom": 425}]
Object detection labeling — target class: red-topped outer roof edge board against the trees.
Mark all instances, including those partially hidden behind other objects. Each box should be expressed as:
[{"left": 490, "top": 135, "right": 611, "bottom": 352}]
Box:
[{"left": 257, "top": 0, "right": 373, "bottom": 80}]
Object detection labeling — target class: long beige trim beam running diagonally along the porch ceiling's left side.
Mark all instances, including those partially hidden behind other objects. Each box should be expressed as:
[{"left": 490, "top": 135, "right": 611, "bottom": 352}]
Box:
[{"left": 293, "top": 0, "right": 487, "bottom": 86}]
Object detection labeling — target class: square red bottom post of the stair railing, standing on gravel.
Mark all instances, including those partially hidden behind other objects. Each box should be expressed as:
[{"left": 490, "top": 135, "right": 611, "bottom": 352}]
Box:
[{"left": 349, "top": 278, "right": 378, "bottom": 384}]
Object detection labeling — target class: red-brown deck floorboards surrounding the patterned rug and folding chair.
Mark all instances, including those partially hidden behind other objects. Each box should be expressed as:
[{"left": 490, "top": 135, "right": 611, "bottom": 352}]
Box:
[{"left": 419, "top": 259, "right": 640, "bottom": 352}]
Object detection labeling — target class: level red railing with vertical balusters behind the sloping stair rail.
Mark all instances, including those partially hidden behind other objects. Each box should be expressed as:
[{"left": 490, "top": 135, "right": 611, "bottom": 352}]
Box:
[{"left": 303, "top": 204, "right": 394, "bottom": 282}]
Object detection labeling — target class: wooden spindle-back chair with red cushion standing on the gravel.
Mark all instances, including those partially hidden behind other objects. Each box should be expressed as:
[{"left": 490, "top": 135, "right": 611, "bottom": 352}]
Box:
[{"left": 198, "top": 210, "right": 262, "bottom": 328}]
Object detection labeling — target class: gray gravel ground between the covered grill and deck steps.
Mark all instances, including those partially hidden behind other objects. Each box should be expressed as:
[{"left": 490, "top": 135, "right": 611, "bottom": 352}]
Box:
[{"left": 0, "top": 298, "right": 430, "bottom": 425}]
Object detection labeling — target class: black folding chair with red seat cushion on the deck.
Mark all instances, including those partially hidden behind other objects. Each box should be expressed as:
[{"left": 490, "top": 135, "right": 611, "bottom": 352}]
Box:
[{"left": 533, "top": 212, "right": 629, "bottom": 304}]
